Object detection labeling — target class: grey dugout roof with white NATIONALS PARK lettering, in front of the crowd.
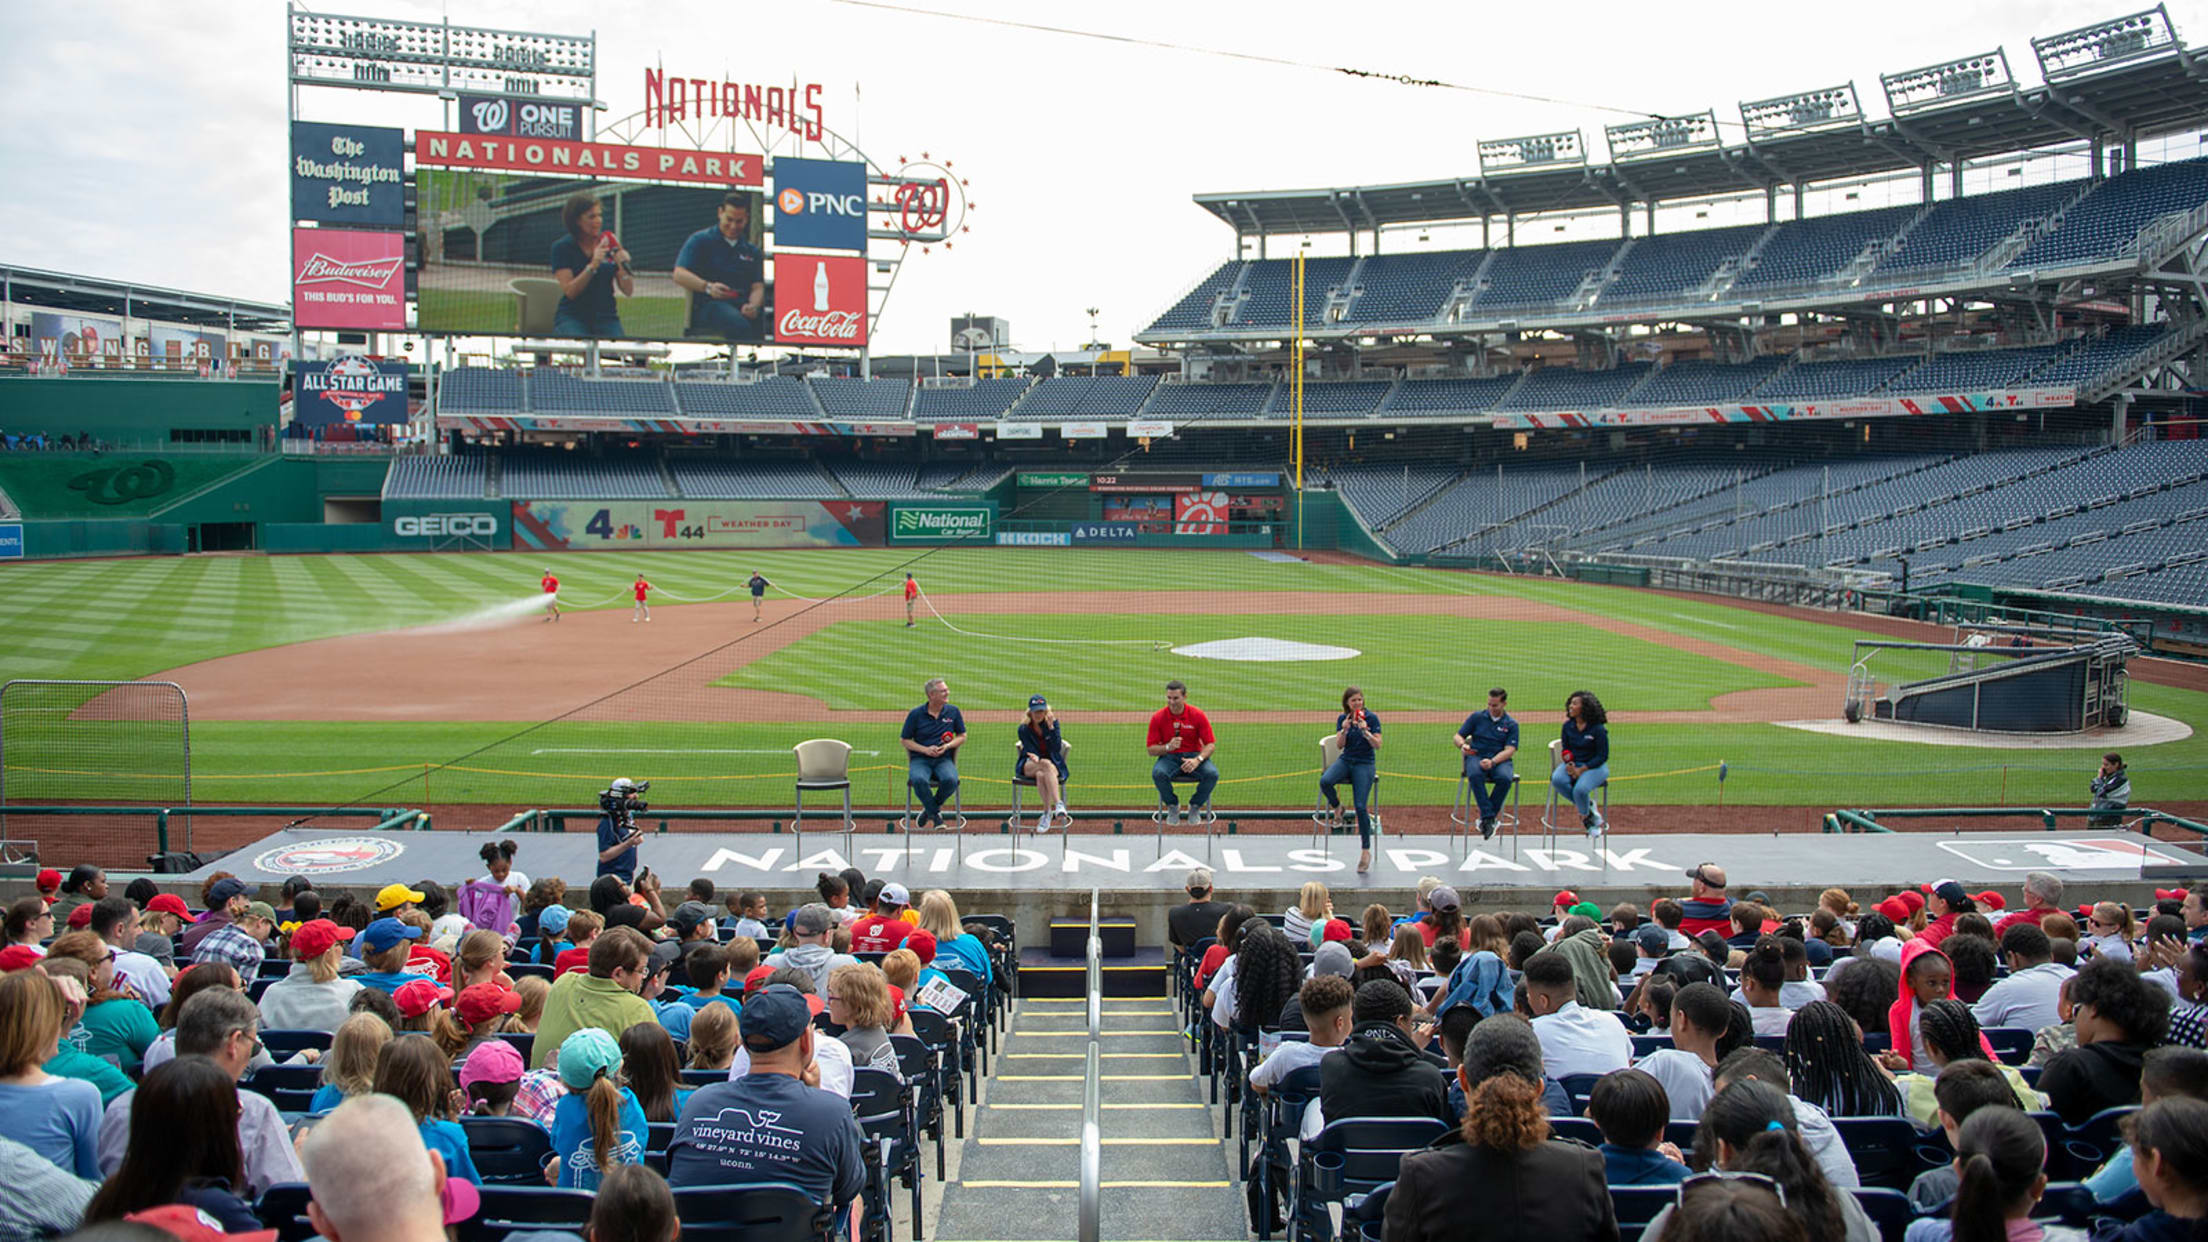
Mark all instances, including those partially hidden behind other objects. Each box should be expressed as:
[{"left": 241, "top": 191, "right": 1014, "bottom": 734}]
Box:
[{"left": 183, "top": 829, "right": 2204, "bottom": 944}]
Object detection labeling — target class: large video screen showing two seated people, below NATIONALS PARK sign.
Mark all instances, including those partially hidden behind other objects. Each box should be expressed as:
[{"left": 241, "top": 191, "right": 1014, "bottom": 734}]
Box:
[{"left": 415, "top": 168, "right": 750, "bottom": 340}]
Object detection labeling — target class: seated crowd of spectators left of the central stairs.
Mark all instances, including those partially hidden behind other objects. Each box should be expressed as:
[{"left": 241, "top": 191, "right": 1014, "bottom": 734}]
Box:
[{"left": 0, "top": 840, "right": 1000, "bottom": 1242}]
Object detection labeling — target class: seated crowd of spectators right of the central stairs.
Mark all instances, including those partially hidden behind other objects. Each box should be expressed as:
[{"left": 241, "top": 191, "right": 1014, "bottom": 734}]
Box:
[{"left": 1168, "top": 862, "right": 2208, "bottom": 1242}]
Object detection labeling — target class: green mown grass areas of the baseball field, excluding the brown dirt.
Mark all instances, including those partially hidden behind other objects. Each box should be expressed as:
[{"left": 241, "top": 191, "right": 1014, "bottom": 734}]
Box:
[{"left": 0, "top": 548, "right": 2208, "bottom": 808}]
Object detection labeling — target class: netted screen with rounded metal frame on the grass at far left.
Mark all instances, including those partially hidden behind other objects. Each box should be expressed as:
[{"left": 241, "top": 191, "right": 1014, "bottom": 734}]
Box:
[{"left": 0, "top": 678, "right": 192, "bottom": 869}]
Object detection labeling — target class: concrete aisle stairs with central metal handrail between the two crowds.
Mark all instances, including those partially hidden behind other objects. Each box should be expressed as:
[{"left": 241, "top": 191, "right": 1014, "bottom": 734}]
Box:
[{"left": 930, "top": 919, "right": 1248, "bottom": 1242}]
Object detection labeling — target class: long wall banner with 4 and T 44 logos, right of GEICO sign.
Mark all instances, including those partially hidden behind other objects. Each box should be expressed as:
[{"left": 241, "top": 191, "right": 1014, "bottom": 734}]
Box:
[{"left": 514, "top": 499, "right": 883, "bottom": 548}]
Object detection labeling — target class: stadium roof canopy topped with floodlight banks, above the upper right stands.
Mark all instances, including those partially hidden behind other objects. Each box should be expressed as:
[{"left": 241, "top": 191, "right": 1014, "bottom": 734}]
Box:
[{"left": 1195, "top": 7, "right": 2208, "bottom": 234}]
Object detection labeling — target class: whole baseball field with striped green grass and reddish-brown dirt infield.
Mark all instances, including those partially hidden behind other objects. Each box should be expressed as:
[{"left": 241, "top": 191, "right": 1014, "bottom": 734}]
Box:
[{"left": 0, "top": 548, "right": 2208, "bottom": 831}]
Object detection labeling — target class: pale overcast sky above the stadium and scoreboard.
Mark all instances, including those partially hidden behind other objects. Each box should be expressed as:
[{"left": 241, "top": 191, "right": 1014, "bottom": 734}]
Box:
[{"left": 0, "top": 0, "right": 2208, "bottom": 354}]
